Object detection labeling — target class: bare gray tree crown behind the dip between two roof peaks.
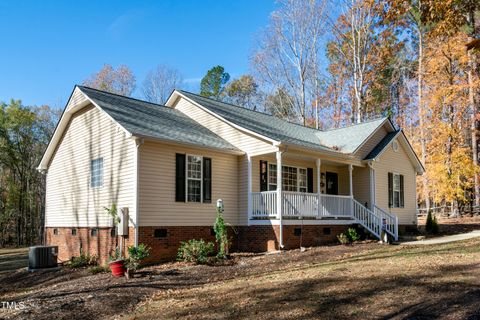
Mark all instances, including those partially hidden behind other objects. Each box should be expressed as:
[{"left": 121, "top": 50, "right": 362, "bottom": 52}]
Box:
[{"left": 142, "top": 65, "right": 183, "bottom": 104}]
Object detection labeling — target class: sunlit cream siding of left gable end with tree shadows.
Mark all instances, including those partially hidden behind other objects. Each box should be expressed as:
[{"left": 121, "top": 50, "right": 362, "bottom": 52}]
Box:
[{"left": 45, "top": 105, "right": 135, "bottom": 227}]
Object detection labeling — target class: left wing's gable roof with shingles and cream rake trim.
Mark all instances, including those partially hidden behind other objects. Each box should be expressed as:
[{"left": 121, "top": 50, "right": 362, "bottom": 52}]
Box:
[{"left": 38, "top": 86, "right": 243, "bottom": 169}]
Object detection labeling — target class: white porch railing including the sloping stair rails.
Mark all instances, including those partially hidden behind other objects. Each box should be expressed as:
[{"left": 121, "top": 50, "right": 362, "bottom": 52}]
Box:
[{"left": 251, "top": 191, "right": 398, "bottom": 240}]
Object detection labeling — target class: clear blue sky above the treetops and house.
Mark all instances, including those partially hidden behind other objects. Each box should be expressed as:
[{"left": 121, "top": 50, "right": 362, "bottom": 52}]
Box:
[{"left": 0, "top": 0, "right": 275, "bottom": 108}]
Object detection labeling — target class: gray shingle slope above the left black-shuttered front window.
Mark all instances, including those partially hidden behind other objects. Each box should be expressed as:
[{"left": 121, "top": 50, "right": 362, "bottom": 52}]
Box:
[{"left": 78, "top": 86, "right": 240, "bottom": 151}]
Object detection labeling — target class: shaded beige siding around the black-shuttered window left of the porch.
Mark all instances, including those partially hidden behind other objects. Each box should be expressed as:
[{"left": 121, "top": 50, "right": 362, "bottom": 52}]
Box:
[{"left": 139, "top": 140, "right": 239, "bottom": 226}]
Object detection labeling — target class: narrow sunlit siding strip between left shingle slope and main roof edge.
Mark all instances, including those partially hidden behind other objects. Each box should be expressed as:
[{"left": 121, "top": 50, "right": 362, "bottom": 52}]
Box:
[{"left": 173, "top": 97, "right": 277, "bottom": 154}]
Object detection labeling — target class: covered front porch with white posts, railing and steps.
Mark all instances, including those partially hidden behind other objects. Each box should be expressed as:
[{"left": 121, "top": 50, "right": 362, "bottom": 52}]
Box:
[{"left": 247, "top": 151, "right": 398, "bottom": 239}]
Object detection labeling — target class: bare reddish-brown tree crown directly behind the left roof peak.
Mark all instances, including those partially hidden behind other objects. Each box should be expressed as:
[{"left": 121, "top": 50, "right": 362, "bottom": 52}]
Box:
[{"left": 83, "top": 64, "right": 136, "bottom": 96}]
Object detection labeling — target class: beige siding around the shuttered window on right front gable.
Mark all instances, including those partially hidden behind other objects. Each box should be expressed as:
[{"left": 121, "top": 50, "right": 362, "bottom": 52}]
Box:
[{"left": 373, "top": 143, "right": 417, "bottom": 224}]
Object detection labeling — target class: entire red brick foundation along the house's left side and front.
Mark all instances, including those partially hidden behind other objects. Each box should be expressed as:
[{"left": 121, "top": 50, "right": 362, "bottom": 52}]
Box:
[{"left": 46, "top": 225, "right": 351, "bottom": 264}]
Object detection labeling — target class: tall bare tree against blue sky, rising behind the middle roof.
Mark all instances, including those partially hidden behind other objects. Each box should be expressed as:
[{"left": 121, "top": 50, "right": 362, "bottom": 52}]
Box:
[{"left": 252, "top": 0, "right": 325, "bottom": 125}]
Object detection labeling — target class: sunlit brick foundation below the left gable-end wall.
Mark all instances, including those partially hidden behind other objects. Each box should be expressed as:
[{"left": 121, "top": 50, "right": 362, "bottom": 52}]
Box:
[{"left": 45, "top": 227, "right": 135, "bottom": 264}]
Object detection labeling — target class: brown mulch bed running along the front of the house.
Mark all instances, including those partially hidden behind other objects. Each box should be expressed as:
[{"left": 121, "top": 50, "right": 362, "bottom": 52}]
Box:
[{"left": 0, "top": 243, "right": 378, "bottom": 319}]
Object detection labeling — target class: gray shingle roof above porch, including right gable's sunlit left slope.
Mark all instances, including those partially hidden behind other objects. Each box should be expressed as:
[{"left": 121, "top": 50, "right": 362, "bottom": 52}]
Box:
[{"left": 179, "top": 90, "right": 386, "bottom": 154}]
